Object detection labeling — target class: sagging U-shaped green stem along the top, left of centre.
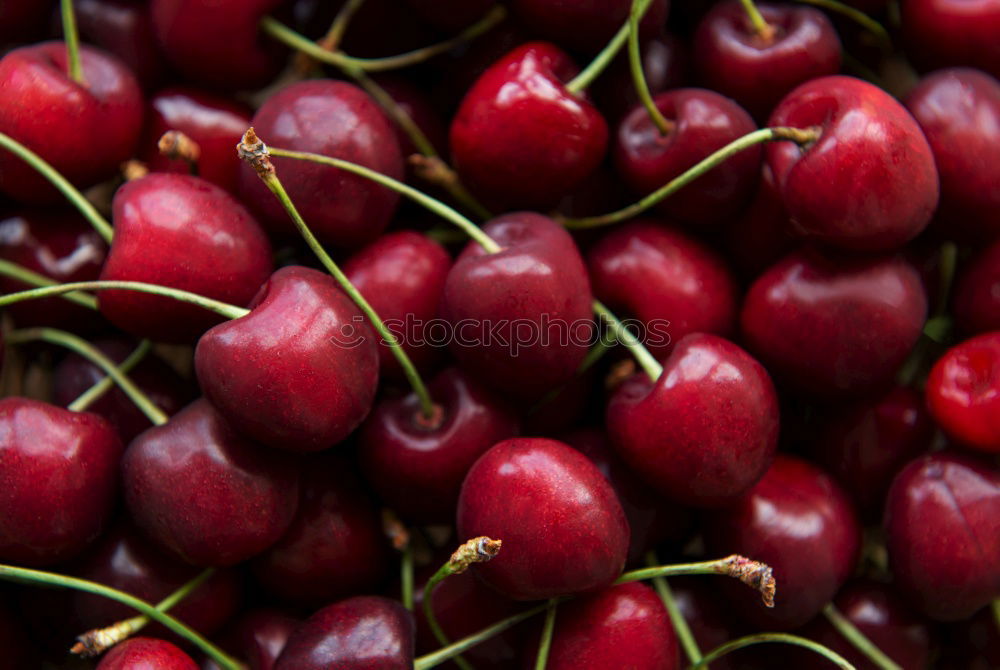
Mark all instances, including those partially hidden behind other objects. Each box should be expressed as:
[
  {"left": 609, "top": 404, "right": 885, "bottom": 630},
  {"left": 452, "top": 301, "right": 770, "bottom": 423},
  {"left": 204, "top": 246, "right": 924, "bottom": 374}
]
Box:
[{"left": 260, "top": 5, "right": 507, "bottom": 72}]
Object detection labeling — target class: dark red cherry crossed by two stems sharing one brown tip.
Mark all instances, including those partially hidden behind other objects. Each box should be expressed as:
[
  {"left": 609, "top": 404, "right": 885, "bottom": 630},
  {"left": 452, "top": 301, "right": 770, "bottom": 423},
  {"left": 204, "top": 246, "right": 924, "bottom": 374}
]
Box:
[{"left": 240, "top": 79, "right": 403, "bottom": 248}]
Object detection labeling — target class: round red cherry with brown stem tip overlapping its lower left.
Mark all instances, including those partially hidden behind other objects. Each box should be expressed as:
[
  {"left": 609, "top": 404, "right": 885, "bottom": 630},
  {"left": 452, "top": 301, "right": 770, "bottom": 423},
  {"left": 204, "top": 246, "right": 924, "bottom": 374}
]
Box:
[{"left": 457, "top": 438, "right": 629, "bottom": 600}]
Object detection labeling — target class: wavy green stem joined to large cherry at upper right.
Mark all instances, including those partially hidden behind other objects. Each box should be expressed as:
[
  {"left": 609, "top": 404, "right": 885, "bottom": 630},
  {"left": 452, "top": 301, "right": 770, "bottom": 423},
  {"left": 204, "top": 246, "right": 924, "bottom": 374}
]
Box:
[{"left": 557, "top": 126, "right": 820, "bottom": 229}]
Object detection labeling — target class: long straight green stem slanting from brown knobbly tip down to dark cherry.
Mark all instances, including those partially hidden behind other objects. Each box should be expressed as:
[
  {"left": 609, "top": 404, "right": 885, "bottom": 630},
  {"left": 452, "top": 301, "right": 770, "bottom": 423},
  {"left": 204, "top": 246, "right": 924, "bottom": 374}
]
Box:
[{"left": 237, "top": 128, "right": 434, "bottom": 417}]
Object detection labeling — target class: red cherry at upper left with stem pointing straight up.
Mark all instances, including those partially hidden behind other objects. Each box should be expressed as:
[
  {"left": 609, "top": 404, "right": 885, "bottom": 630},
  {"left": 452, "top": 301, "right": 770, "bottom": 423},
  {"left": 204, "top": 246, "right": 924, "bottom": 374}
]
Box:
[{"left": 0, "top": 42, "right": 143, "bottom": 203}]
